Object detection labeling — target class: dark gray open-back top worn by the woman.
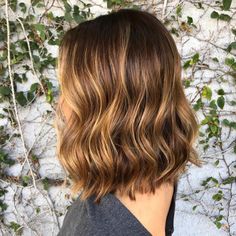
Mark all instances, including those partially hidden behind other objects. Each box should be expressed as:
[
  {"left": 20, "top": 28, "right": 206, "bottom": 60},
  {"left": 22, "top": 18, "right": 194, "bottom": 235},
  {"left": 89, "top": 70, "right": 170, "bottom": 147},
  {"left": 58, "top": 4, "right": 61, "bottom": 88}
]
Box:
[{"left": 57, "top": 184, "right": 177, "bottom": 236}]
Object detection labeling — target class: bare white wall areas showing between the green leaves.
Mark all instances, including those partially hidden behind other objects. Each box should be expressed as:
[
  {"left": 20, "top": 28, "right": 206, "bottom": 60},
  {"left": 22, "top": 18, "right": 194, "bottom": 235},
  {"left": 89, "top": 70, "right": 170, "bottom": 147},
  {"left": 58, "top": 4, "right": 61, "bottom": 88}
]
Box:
[{"left": 0, "top": 0, "right": 236, "bottom": 236}]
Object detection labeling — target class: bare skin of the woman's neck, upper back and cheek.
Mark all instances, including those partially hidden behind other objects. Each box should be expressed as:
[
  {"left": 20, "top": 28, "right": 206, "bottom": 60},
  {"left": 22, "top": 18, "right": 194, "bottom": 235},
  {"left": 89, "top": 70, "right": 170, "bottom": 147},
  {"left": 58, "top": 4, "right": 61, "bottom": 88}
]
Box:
[{"left": 59, "top": 96, "right": 174, "bottom": 236}]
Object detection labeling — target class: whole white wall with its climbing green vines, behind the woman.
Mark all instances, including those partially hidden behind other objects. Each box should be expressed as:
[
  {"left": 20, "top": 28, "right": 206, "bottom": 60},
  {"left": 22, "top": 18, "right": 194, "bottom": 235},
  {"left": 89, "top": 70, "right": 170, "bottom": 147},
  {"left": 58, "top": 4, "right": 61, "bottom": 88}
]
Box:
[{"left": 0, "top": 0, "right": 236, "bottom": 236}]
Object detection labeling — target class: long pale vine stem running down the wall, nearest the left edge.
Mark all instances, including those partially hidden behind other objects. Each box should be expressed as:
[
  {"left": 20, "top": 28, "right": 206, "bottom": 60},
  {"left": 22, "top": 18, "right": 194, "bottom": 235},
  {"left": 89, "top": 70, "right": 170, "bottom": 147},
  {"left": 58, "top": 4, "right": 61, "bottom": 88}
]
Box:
[{"left": 5, "top": 0, "right": 37, "bottom": 189}]
